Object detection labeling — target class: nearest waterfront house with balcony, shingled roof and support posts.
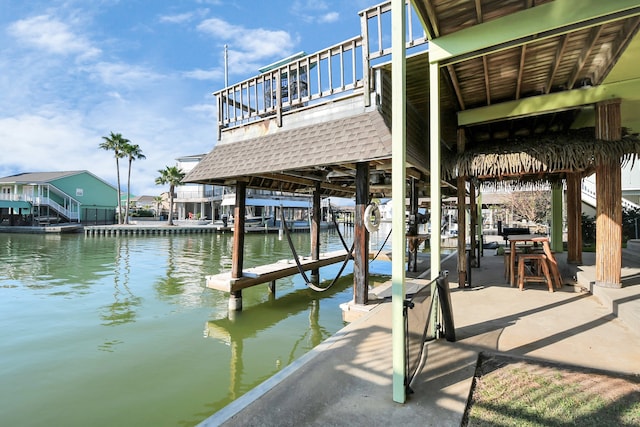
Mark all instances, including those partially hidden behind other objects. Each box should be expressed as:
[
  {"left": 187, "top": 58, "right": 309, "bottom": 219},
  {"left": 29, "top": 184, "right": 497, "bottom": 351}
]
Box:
[{"left": 181, "top": 0, "right": 640, "bottom": 408}]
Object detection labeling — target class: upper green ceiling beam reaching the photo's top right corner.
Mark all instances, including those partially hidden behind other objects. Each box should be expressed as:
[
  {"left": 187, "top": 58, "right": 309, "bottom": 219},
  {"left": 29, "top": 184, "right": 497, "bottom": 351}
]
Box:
[{"left": 429, "top": 0, "right": 640, "bottom": 65}]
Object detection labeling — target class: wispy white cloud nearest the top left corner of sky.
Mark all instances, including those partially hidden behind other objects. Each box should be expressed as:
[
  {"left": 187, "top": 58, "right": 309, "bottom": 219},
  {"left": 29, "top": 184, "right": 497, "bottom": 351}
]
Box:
[{"left": 8, "top": 15, "right": 101, "bottom": 58}]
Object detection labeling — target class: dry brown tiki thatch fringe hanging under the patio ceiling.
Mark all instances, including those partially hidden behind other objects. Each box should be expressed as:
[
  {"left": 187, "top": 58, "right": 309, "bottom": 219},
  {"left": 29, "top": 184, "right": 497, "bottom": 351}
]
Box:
[{"left": 443, "top": 128, "right": 640, "bottom": 181}]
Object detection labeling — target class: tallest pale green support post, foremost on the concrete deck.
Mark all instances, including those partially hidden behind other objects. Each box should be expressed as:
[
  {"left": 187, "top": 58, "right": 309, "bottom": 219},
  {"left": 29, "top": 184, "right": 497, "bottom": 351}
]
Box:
[{"left": 391, "top": 0, "right": 407, "bottom": 403}]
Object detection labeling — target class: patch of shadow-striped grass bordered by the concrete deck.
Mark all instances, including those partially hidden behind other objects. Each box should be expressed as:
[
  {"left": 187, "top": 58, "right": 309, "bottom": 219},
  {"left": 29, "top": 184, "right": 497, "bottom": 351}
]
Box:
[{"left": 462, "top": 355, "right": 640, "bottom": 426}]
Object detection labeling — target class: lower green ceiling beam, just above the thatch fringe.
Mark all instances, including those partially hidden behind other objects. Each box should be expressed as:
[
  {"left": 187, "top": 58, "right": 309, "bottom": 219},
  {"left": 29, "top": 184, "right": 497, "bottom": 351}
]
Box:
[{"left": 458, "top": 78, "right": 640, "bottom": 126}]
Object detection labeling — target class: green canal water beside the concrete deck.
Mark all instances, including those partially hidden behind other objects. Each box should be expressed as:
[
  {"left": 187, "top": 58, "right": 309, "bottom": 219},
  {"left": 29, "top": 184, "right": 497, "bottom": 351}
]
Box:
[{"left": 0, "top": 226, "right": 390, "bottom": 426}]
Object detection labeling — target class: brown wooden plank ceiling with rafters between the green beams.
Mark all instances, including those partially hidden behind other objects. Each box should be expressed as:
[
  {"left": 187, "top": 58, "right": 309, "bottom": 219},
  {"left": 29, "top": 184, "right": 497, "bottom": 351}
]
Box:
[{"left": 407, "top": 0, "right": 640, "bottom": 144}]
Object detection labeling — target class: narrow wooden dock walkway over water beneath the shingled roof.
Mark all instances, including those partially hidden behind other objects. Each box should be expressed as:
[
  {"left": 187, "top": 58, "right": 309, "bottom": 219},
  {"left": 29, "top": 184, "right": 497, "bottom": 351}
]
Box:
[{"left": 206, "top": 250, "right": 347, "bottom": 292}]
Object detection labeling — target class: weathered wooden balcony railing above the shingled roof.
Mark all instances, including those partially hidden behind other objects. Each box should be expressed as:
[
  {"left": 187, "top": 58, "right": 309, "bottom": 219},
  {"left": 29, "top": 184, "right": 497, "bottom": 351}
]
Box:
[{"left": 214, "top": 0, "right": 427, "bottom": 138}]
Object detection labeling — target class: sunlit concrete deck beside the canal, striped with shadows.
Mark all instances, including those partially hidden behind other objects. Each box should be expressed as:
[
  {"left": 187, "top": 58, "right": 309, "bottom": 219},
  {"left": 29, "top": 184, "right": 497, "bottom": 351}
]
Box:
[{"left": 201, "top": 244, "right": 640, "bottom": 426}]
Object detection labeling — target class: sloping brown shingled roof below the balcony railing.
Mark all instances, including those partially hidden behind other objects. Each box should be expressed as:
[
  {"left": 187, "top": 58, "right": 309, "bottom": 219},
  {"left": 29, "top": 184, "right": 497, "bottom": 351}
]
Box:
[{"left": 184, "top": 111, "right": 391, "bottom": 195}]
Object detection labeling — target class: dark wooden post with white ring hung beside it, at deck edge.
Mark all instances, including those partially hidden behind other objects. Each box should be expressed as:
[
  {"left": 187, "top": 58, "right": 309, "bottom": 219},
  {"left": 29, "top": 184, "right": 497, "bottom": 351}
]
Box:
[{"left": 353, "top": 162, "right": 369, "bottom": 305}]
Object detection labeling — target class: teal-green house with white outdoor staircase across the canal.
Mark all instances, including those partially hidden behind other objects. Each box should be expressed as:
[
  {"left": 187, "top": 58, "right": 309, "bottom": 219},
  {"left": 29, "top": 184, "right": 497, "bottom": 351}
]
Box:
[{"left": 0, "top": 170, "right": 118, "bottom": 225}]
